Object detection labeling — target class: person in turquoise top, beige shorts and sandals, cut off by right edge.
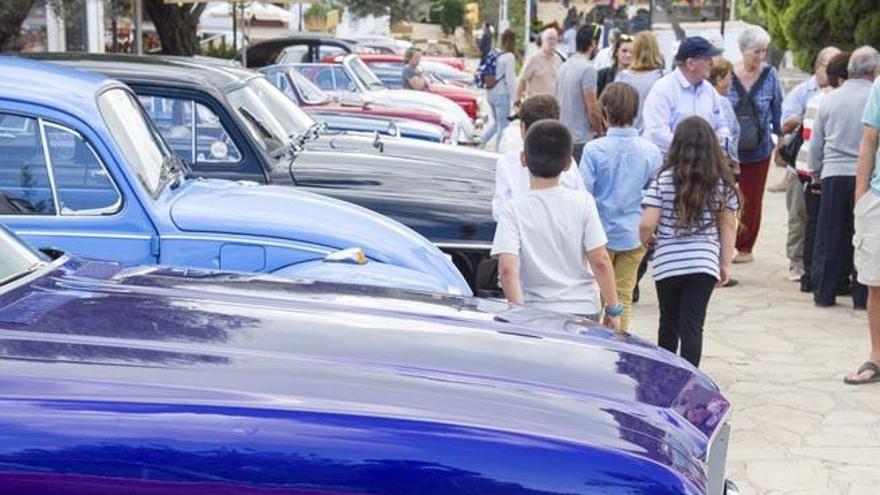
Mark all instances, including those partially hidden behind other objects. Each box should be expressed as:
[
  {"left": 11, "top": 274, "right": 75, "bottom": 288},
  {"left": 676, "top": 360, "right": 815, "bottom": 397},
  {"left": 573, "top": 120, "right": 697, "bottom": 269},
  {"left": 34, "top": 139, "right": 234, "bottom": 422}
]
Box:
[{"left": 844, "top": 52, "right": 880, "bottom": 385}]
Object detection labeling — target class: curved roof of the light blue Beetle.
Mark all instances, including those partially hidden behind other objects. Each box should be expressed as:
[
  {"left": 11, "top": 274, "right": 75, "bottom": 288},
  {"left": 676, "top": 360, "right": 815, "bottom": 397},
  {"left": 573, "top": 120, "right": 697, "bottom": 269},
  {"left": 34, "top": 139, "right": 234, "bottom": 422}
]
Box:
[{"left": 0, "top": 56, "right": 124, "bottom": 129}]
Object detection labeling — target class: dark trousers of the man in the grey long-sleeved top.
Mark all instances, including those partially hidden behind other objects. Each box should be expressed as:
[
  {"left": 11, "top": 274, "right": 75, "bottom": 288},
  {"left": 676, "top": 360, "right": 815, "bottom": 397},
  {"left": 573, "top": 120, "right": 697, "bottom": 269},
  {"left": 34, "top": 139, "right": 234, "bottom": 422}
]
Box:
[{"left": 810, "top": 176, "right": 868, "bottom": 307}]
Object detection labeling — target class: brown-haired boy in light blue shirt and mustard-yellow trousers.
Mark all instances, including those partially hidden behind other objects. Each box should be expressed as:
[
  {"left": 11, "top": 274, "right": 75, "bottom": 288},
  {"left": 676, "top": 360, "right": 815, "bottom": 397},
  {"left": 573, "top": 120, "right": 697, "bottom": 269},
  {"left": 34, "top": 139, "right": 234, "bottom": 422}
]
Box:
[{"left": 580, "top": 82, "right": 663, "bottom": 330}]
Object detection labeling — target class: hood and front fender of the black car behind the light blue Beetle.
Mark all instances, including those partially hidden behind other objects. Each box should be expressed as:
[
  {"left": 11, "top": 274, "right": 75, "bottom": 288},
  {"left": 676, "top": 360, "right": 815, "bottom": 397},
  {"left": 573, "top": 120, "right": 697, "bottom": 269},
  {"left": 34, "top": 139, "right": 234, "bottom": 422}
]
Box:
[{"left": 293, "top": 134, "right": 497, "bottom": 248}]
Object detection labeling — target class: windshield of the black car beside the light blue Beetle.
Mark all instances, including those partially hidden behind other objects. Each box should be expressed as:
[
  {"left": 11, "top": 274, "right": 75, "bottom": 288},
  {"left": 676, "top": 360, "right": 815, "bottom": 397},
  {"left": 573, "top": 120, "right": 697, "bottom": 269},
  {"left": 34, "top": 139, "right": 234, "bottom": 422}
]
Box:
[{"left": 226, "top": 77, "right": 315, "bottom": 154}]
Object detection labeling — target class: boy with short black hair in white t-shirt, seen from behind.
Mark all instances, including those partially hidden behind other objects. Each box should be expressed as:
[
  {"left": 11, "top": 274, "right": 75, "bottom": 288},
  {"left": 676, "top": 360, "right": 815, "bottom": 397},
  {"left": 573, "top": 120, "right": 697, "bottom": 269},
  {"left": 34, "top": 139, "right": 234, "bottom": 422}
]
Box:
[{"left": 492, "top": 119, "right": 623, "bottom": 329}]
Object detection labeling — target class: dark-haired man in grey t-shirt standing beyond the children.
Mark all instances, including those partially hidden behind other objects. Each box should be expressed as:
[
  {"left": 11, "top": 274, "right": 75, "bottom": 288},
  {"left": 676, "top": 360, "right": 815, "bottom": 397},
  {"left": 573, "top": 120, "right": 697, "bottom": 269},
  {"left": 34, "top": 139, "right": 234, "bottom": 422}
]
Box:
[{"left": 556, "top": 24, "right": 603, "bottom": 163}]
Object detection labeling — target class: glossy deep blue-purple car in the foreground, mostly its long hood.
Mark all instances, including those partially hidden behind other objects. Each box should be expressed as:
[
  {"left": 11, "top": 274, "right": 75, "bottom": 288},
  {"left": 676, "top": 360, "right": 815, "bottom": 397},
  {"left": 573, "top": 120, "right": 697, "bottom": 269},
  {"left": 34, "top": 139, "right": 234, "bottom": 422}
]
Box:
[{"left": 0, "top": 229, "right": 733, "bottom": 495}]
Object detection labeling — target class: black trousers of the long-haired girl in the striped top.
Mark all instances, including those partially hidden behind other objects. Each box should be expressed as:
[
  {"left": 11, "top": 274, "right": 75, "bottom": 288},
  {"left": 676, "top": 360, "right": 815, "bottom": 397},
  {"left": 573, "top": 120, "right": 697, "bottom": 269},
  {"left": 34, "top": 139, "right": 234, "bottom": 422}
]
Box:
[{"left": 655, "top": 273, "right": 718, "bottom": 366}]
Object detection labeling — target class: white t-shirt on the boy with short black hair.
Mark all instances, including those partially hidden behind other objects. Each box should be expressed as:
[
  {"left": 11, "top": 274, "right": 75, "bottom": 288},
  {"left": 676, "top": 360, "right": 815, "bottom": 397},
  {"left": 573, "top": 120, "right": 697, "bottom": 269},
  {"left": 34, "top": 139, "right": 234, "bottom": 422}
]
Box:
[{"left": 492, "top": 186, "right": 607, "bottom": 315}]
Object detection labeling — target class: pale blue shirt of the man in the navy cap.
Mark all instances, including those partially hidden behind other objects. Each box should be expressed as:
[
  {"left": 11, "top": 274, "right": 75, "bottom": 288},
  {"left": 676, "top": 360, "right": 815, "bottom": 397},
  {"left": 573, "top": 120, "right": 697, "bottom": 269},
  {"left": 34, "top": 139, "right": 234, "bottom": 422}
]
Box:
[{"left": 643, "top": 69, "right": 730, "bottom": 154}]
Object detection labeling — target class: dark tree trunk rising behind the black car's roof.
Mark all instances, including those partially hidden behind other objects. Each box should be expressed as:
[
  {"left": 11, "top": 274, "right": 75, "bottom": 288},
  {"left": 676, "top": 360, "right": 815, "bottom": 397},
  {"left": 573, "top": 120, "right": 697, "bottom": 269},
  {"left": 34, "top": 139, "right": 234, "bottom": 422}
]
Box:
[{"left": 144, "top": 0, "right": 207, "bottom": 55}]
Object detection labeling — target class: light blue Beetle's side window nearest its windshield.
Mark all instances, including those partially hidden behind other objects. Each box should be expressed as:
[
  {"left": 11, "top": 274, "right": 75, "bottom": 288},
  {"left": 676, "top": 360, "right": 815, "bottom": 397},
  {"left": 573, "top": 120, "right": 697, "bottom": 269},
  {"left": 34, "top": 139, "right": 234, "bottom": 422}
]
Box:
[{"left": 43, "top": 122, "right": 122, "bottom": 215}]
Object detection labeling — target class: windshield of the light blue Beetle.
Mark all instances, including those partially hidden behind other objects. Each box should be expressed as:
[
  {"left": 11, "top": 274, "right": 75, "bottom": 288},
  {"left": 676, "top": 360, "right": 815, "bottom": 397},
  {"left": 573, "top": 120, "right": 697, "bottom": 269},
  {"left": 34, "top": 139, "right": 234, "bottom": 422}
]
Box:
[{"left": 98, "top": 88, "right": 173, "bottom": 197}]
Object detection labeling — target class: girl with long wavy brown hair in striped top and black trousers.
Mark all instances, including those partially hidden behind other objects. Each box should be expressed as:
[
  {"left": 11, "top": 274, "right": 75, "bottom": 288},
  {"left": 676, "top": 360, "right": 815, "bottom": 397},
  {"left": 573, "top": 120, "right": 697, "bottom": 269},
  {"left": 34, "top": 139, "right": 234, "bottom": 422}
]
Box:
[{"left": 640, "top": 116, "right": 741, "bottom": 366}]
